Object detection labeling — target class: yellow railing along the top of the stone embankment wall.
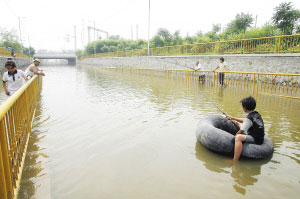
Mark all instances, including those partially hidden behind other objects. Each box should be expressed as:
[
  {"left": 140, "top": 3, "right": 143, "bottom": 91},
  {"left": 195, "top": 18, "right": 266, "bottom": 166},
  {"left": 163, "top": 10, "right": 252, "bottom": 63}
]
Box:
[{"left": 81, "top": 34, "right": 300, "bottom": 59}]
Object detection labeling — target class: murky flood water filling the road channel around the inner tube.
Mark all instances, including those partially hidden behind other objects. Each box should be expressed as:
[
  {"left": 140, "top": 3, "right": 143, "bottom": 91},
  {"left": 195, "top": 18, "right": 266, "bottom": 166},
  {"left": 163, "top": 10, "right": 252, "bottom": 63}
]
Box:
[{"left": 19, "top": 66, "right": 300, "bottom": 199}]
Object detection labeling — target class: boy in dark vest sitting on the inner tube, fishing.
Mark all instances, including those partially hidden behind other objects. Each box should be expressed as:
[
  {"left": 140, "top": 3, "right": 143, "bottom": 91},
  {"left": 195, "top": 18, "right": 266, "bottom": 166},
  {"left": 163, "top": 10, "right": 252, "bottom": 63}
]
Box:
[{"left": 226, "top": 96, "right": 265, "bottom": 161}]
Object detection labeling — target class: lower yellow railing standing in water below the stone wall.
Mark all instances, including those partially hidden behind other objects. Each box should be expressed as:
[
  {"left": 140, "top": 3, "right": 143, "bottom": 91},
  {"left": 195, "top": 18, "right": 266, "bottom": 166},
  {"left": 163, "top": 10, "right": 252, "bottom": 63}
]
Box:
[{"left": 96, "top": 67, "right": 300, "bottom": 100}]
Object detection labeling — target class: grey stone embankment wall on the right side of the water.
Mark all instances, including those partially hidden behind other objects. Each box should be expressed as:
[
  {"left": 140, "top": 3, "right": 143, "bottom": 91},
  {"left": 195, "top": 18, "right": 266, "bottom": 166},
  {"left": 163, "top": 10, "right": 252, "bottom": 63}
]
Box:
[{"left": 77, "top": 53, "right": 300, "bottom": 73}]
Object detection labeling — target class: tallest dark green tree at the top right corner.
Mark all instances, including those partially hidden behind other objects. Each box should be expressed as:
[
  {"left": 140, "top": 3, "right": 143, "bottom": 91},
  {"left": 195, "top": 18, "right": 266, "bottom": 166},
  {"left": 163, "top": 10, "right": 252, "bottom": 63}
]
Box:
[{"left": 272, "top": 2, "right": 300, "bottom": 35}]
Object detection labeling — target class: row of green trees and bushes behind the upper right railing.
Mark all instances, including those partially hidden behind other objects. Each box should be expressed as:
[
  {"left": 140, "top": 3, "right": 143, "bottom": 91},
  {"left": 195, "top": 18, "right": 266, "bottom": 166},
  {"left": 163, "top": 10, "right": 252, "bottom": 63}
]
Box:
[{"left": 76, "top": 2, "right": 300, "bottom": 57}]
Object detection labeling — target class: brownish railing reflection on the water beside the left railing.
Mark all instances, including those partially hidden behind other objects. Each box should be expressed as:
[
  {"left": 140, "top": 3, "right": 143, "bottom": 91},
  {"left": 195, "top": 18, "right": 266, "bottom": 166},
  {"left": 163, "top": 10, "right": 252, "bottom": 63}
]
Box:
[{"left": 18, "top": 97, "right": 50, "bottom": 199}]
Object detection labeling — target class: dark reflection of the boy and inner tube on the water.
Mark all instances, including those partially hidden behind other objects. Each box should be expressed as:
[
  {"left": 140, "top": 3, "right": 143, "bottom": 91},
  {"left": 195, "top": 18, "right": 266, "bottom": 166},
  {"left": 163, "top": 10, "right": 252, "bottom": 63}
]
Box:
[{"left": 195, "top": 142, "right": 271, "bottom": 195}]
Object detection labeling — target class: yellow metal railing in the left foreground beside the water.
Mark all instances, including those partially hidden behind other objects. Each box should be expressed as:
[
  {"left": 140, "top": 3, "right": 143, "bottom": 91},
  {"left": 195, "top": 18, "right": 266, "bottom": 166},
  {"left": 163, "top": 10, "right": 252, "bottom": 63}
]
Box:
[{"left": 0, "top": 76, "right": 42, "bottom": 199}]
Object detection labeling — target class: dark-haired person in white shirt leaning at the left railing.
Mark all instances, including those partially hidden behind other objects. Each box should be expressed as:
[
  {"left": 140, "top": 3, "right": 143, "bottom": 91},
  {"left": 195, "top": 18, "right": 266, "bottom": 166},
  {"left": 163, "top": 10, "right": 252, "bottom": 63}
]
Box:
[{"left": 2, "top": 60, "right": 28, "bottom": 96}]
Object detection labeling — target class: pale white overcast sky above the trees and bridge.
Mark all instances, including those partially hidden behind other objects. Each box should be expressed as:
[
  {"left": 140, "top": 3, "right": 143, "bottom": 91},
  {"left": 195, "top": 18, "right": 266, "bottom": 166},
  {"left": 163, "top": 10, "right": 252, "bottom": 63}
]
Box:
[{"left": 0, "top": 0, "right": 300, "bottom": 50}]
